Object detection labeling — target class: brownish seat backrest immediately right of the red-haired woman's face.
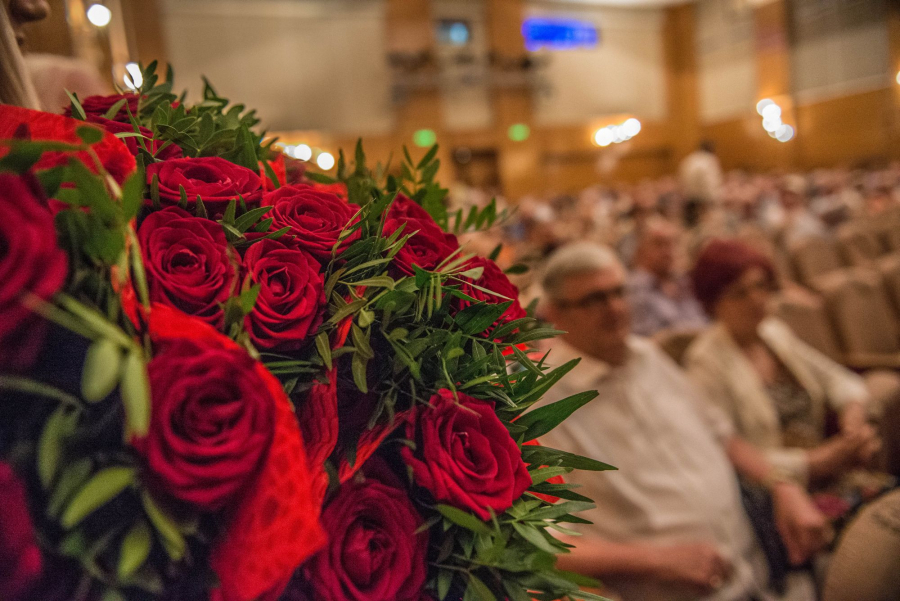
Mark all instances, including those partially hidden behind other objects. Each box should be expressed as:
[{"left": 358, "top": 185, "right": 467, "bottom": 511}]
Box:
[{"left": 772, "top": 287, "right": 841, "bottom": 361}]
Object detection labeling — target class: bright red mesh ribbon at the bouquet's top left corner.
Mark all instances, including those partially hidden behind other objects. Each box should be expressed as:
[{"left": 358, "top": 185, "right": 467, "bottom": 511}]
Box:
[{"left": 0, "top": 105, "right": 137, "bottom": 184}]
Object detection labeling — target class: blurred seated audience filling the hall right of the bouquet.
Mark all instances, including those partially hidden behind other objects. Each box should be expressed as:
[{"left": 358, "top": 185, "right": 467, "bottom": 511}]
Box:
[{"left": 454, "top": 144, "right": 900, "bottom": 601}]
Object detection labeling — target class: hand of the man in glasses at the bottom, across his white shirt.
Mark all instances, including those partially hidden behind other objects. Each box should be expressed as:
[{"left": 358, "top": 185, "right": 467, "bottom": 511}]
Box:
[{"left": 654, "top": 543, "right": 733, "bottom": 595}]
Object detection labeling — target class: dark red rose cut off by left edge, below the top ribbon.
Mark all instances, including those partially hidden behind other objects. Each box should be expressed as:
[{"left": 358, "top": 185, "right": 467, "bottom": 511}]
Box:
[{"left": 0, "top": 173, "right": 68, "bottom": 372}]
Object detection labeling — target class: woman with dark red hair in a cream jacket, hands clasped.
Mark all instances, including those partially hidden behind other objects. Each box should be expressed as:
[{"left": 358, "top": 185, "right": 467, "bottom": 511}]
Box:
[{"left": 686, "top": 240, "right": 880, "bottom": 484}]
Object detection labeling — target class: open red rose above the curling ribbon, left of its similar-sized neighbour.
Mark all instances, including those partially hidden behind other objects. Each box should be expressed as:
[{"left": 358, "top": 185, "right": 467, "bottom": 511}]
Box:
[{"left": 138, "top": 207, "right": 235, "bottom": 327}]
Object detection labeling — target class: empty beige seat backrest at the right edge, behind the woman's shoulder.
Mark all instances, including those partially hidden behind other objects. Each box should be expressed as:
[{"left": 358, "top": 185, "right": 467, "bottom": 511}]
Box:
[{"left": 816, "top": 268, "right": 900, "bottom": 354}]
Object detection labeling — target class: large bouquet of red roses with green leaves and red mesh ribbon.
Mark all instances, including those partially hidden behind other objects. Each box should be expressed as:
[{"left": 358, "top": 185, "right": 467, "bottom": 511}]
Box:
[{"left": 0, "top": 65, "right": 608, "bottom": 601}]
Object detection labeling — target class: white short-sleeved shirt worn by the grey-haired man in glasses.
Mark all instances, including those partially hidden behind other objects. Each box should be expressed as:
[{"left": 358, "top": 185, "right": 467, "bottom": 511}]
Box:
[{"left": 541, "top": 337, "right": 770, "bottom": 601}]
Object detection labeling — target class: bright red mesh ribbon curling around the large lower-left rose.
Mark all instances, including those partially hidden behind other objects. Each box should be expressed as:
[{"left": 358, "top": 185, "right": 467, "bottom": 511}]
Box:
[{"left": 139, "top": 304, "right": 325, "bottom": 601}]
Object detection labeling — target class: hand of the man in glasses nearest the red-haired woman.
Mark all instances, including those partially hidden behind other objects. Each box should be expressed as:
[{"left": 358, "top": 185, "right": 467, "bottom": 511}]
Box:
[{"left": 772, "top": 482, "right": 834, "bottom": 565}]
